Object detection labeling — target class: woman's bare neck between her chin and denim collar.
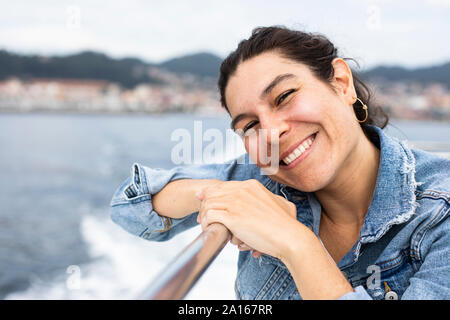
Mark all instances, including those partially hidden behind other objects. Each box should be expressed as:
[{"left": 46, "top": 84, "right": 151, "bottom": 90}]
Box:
[{"left": 315, "top": 135, "right": 380, "bottom": 228}]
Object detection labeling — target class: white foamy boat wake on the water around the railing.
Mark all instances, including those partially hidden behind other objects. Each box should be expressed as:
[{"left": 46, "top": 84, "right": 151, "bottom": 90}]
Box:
[{"left": 6, "top": 215, "right": 238, "bottom": 300}]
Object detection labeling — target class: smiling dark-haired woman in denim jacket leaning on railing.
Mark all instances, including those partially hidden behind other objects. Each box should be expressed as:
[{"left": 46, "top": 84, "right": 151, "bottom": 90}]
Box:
[{"left": 111, "top": 27, "right": 450, "bottom": 299}]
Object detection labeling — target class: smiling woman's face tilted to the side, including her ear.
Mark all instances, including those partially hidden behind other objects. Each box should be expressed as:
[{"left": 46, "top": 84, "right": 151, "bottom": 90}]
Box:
[{"left": 229, "top": 52, "right": 364, "bottom": 192}]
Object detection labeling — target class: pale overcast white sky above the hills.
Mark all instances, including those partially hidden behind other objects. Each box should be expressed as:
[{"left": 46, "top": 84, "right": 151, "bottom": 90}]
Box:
[{"left": 0, "top": 0, "right": 450, "bottom": 69}]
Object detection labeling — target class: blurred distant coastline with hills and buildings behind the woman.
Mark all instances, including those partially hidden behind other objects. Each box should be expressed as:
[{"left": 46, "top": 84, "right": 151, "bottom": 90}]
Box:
[{"left": 0, "top": 50, "right": 450, "bottom": 121}]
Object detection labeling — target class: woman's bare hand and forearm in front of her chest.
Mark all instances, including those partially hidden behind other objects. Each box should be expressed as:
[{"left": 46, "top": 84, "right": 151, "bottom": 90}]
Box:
[{"left": 197, "top": 180, "right": 353, "bottom": 299}]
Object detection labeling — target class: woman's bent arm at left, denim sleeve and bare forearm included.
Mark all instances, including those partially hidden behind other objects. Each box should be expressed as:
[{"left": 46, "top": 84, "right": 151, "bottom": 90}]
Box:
[{"left": 110, "top": 155, "right": 261, "bottom": 241}]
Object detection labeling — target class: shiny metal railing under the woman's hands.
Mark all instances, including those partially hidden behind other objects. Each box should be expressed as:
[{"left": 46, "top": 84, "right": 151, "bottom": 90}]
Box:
[{"left": 137, "top": 223, "right": 231, "bottom": 300}]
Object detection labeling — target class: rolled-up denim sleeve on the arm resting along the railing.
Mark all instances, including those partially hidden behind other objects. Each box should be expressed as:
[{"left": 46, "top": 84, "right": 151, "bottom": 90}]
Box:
[{"left": 110, "top": 155, "right": 261, "bottom": 241}]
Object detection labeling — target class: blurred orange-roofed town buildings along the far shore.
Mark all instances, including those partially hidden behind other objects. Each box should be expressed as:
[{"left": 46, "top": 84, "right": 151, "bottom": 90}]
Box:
[{"left": 0, "top": 76, "right": 450, "bottom": 121}]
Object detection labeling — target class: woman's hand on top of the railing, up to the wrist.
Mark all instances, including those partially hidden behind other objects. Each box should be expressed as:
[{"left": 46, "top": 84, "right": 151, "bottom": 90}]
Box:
[{"left": 197, "top": 179, "right": 300, "bottom": 259}]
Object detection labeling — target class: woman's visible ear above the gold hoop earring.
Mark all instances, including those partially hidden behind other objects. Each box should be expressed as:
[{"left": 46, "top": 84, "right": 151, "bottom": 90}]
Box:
[{"left": 331, "top": 58, "right": 356, "bottom": 104}]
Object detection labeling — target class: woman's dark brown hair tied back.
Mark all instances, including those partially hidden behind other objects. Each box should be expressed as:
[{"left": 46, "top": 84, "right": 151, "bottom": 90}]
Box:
[{"left": 218, "top": 26, "right": 389, "bottom": 141}]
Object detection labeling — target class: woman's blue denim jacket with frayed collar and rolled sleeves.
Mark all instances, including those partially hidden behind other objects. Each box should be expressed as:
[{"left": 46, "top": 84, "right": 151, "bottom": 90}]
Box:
[{"left": 111, "top": 126, "right": 450, "bottom": 300}]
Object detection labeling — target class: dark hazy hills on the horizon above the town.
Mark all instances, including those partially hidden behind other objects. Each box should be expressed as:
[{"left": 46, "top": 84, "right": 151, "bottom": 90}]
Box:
[{"left": 0, "top": 50, "right": 450, "bottom": 88}]
